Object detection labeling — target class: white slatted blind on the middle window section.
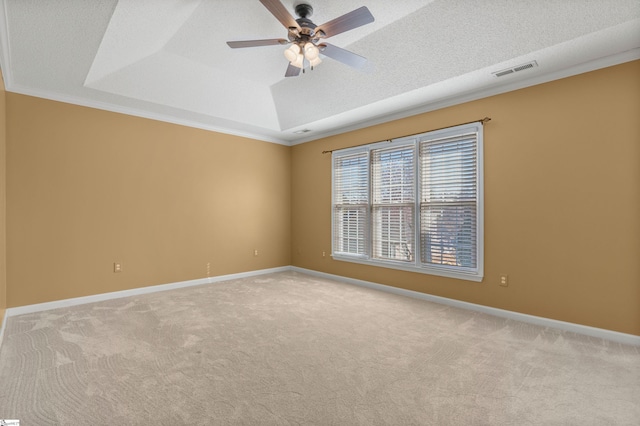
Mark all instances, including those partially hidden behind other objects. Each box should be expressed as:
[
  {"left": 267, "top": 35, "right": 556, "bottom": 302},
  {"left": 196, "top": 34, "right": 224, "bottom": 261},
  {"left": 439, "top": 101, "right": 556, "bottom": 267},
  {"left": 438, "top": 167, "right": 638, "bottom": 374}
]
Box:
[{"left": 371, "top": 145, "right": 416, "bottom": 262}]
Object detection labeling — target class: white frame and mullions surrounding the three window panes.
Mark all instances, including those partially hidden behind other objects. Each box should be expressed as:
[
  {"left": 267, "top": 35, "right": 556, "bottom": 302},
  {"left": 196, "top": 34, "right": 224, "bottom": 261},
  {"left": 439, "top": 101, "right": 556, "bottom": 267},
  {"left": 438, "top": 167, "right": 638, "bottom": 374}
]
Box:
[{"left": 331, "top": 122, "right": 484, "bottom": 282}]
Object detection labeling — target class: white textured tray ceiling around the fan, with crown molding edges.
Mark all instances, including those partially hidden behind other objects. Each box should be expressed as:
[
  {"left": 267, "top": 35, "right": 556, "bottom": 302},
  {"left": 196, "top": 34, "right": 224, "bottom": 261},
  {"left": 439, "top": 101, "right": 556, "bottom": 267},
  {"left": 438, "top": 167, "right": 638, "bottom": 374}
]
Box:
[{"left": 0, "top": 0, "right": 640, "bottom": 145}]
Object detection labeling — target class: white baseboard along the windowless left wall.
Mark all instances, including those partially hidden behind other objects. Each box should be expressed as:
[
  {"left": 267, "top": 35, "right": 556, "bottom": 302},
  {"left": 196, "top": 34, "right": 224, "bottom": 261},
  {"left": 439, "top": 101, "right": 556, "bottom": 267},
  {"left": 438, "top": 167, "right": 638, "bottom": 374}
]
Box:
[{"left": 0, "top": 266, "right": 291, "bottom": 320}]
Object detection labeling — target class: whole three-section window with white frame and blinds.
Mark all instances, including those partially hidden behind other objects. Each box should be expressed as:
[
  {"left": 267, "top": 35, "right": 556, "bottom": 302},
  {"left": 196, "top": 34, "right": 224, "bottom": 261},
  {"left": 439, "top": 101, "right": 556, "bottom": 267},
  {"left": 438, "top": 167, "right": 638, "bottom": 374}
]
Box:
[{"left": 332, "top": 123, "right": 483, "bottom": 281}]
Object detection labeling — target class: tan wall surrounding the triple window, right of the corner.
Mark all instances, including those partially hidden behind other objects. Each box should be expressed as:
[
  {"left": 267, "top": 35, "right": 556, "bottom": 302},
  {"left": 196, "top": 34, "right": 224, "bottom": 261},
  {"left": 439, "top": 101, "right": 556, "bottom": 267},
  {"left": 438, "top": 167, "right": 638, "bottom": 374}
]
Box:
[{"left": 291, "top": 61, "right": 640, "bottom": 335}]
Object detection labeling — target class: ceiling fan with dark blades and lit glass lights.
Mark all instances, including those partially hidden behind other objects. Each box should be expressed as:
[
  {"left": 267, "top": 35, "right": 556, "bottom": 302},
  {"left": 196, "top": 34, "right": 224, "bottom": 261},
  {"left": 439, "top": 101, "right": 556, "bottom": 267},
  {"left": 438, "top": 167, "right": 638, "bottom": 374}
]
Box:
[{"left": 227, "top": 0, "right": 374, "bottom": 77}]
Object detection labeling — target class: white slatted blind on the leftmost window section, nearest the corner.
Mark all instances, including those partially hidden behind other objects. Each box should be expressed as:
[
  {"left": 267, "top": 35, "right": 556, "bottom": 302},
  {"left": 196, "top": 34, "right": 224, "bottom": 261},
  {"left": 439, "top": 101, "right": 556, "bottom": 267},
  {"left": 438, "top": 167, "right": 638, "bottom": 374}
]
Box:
[{"left": 333, "top": 151, "right": 369, "bottom": 256}]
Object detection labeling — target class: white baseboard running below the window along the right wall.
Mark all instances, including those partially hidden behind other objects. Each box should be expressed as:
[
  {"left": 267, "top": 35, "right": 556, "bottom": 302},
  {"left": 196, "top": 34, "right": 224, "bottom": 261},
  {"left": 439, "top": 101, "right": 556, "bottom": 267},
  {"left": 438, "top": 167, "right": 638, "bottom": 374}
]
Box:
[{"left": 291, "top": 266, "right": 640, "bottom": 346}]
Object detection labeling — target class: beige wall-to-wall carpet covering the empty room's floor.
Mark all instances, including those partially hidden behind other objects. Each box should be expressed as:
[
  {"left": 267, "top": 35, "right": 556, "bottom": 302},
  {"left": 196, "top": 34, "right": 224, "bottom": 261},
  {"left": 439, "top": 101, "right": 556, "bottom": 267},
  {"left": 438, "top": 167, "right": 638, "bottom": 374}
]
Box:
[{"left": 0, "top": 272, "right": 640, "bottom": 426}]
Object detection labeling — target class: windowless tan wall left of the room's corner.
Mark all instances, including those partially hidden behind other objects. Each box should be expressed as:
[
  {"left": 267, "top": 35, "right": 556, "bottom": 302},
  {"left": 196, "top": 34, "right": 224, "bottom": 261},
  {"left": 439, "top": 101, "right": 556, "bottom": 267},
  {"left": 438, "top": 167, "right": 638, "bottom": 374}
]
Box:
[{"left": 7, "top": 93, "right": 291, "bottom": 307}]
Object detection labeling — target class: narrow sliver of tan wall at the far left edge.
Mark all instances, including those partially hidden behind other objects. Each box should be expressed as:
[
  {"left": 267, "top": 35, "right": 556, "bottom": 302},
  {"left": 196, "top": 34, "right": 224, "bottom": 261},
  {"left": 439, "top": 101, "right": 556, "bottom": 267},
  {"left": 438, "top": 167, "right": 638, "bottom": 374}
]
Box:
[{"left": 0, "top": 72, "right": 7, "bottom": 328}]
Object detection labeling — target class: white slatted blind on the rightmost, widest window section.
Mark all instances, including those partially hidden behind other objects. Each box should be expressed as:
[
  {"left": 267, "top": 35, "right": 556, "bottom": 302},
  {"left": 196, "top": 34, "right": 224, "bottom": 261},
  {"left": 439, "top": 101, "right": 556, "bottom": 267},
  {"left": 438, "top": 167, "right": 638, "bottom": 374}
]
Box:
[{"left": 420, "top": 133, "right": 478, "bottom": 268}]
